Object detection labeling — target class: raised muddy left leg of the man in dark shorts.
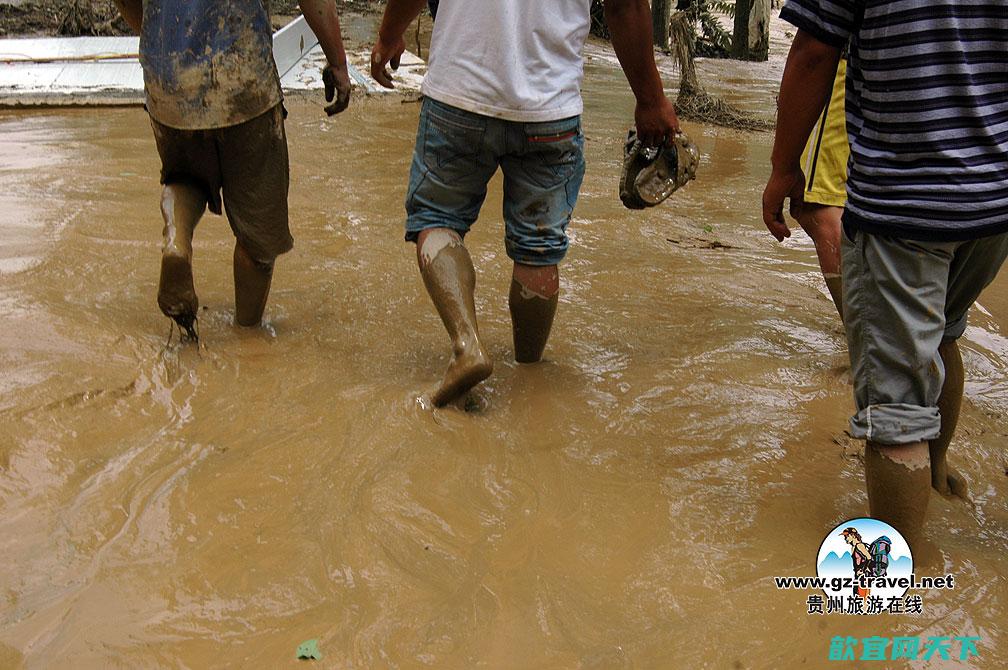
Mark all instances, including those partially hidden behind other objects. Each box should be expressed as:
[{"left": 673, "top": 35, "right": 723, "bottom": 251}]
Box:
[{"left": 157, "top": 183, "right": 207, "bottom": 337}]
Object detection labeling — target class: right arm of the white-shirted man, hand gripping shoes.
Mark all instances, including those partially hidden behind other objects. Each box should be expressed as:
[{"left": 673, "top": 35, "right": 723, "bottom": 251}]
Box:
[{"left": 606, "top": 0, "right": 679, "bottom": 146}]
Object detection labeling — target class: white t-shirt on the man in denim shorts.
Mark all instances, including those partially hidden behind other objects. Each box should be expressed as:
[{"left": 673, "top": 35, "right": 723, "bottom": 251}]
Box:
[{"left": 422, "top": 0, "right": 591, "bottom": 122}]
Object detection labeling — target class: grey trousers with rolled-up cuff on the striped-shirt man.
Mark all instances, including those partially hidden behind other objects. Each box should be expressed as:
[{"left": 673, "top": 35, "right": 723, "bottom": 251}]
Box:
[{"left": 841, "top": 231, "right": 1008, "bottom": 444}]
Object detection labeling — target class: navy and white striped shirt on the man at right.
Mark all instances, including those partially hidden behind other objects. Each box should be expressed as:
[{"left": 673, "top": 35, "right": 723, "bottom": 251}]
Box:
[{"left": 780, "top": 0, "right": 1008, "bottom": 240}]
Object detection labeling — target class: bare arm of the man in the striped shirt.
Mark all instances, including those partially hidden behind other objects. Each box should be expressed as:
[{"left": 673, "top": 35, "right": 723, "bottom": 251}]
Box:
[{"left": 763, "top": 29, "right": 840, "bottom": 242}]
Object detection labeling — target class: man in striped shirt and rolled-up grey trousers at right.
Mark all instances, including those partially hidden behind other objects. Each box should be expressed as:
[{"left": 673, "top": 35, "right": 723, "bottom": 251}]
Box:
[{"left": 763, "top": 0, "right": 1008, "bottom": 542}]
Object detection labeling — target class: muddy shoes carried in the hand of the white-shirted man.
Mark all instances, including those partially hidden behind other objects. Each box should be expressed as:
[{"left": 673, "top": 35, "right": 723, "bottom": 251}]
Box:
[{"left": 620, "top": 130, "right": 700, "bottom": 210}]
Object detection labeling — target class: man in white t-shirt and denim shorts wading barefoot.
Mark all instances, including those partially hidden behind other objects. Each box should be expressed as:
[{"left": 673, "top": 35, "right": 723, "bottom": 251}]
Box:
[{"left": 371, "top": 0, "right": 678, "bottom": 406}]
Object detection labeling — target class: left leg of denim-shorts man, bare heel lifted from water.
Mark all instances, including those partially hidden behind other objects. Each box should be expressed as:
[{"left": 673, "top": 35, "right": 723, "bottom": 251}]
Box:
[{"left": 416, "top": 228, "right": 494, "bottom": 407}]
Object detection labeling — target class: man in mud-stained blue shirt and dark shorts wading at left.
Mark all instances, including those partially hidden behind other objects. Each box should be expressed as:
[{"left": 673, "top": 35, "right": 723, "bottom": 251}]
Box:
[{"left": 116, "top": 0, "right": 350, "bottom": 338}]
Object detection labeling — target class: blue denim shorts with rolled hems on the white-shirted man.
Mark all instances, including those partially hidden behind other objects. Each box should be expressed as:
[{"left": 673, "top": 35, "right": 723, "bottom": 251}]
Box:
[{"left": 406, "top": 98, "right": 585, "bottom": 265}]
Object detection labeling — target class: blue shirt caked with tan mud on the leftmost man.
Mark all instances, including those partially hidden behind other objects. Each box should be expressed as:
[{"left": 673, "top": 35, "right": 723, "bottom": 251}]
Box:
[{"left": 140, "top": 0, "right": 280, "bottom": 130}]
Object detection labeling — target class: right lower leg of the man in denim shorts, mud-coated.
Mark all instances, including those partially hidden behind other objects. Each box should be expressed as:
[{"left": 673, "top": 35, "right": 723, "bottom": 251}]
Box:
[{"left": 508, "top": 263, "right": 560, "bottom": 363}]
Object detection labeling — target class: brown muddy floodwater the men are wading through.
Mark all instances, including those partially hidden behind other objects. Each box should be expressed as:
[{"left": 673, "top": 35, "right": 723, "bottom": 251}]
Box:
[{"left": 0, "top": 54, "right": 1008, "bottom": 668}]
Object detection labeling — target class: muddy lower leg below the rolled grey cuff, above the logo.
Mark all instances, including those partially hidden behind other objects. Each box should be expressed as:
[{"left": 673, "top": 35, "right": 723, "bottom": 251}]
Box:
[{"left": 865, "top": 442, "right": 931, "bottom": 543}]
